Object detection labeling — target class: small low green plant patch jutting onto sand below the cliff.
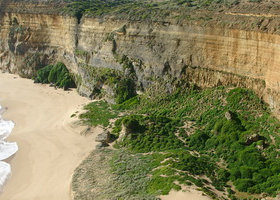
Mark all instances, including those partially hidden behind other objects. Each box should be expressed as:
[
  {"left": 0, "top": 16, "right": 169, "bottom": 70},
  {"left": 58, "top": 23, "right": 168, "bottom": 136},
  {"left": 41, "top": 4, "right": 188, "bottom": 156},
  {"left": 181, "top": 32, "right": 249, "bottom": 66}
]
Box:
[{"left": 79, "top": 101, "right": 118, "bottom": 127}]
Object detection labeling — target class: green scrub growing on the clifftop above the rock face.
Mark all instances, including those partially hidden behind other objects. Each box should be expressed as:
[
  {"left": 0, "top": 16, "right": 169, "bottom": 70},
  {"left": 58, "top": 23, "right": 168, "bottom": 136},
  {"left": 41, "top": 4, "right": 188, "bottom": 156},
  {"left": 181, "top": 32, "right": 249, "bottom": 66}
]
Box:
[{"left": 63, "top": 0, "right": 245, "bottom": 22}]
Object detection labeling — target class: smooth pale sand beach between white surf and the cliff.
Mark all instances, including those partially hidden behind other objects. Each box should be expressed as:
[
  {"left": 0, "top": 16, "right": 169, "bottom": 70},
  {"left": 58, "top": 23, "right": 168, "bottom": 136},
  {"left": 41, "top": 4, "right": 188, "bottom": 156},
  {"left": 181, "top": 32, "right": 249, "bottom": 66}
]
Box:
[{"left": 0, "top": 73, "right": 98, "bottom": 200}]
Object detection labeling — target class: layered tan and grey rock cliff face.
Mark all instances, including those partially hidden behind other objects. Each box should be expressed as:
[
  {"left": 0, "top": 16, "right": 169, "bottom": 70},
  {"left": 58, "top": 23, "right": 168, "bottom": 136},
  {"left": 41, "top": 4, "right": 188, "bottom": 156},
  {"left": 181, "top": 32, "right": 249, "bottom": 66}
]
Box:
[{"left": 0, "top": 1, "right": 280, "bottom": 114}]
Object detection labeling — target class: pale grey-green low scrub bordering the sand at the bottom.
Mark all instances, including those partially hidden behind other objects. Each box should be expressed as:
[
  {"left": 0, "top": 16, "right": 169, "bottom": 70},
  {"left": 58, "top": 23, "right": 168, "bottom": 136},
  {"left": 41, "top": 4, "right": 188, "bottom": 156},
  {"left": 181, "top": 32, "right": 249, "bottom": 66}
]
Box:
[{"left": 72, "top": 150, "right": 159, "bottom": 200}]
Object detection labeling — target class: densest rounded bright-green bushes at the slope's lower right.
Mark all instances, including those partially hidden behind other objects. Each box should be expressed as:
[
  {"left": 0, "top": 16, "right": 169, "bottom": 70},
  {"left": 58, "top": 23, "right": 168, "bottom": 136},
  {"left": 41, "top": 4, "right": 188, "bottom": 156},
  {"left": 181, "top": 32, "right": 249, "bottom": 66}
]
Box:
[{"left": 189, "top": 112, "right": 280, "bottom": 194}]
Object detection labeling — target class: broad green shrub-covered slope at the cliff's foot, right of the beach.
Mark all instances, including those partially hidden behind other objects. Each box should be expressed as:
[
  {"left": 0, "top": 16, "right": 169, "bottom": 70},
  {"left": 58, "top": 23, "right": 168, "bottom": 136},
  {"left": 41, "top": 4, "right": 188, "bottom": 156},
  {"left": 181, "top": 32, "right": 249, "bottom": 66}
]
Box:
[{"left": 74, "top": 87, "right": 280, "bottom": 199}]
